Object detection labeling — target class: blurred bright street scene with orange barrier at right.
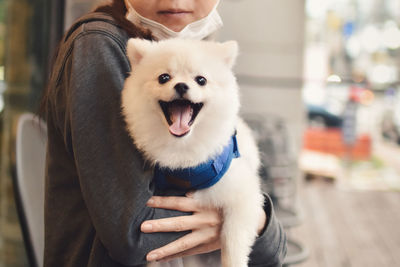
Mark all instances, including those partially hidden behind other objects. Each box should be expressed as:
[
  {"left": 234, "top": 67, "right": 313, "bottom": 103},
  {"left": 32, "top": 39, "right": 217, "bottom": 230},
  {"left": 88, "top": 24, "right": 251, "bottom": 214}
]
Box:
[{"left": 302, "top": 0, "right": 400, "bottom": 190}]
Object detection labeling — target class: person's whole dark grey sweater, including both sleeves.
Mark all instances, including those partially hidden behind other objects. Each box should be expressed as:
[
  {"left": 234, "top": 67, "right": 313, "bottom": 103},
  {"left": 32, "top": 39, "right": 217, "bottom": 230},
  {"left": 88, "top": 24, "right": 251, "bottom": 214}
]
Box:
[{"left": 44, "top": 13, "right": 286, "bottom": 267}]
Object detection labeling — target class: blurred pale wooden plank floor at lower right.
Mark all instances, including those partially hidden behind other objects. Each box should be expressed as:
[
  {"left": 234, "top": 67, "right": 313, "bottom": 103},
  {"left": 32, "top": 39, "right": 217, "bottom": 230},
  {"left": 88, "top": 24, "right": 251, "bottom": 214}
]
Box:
[{"left": 289, "top": 179, "right": 400, "bottom": 267}]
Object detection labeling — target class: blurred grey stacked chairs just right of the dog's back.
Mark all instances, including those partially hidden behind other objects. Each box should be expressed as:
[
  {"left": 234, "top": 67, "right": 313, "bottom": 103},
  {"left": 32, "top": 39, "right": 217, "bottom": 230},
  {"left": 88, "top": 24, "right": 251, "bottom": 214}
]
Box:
[{"left": 243, "top": 114, "right": 309, "bottom": 267}]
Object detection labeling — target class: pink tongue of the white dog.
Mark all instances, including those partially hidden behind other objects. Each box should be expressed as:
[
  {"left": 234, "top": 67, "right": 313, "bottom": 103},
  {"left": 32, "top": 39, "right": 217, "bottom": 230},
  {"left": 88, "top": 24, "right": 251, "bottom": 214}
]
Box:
[{"left": 169, "top": 105, "right": 192, "bottom": 136}]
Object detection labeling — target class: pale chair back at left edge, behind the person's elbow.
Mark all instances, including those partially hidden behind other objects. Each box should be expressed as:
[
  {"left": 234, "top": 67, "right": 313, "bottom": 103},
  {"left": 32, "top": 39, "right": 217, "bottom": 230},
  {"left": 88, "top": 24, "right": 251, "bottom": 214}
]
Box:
[{"left": 14, "top": 113, "right": 47, "bottom": 267}]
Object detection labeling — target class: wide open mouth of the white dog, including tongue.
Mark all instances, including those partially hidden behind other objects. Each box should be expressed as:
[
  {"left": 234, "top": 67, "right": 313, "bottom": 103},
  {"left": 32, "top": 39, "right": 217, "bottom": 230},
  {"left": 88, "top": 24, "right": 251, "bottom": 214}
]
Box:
[{"left": 159, "top": 99, "right": 203, "bottom": 137}]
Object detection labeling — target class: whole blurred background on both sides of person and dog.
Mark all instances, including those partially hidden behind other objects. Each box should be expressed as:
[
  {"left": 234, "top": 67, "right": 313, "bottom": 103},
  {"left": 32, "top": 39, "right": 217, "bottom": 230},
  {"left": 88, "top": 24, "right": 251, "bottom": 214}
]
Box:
[{"left": 0, "top": 0, "right": 400, "bottom": 267}]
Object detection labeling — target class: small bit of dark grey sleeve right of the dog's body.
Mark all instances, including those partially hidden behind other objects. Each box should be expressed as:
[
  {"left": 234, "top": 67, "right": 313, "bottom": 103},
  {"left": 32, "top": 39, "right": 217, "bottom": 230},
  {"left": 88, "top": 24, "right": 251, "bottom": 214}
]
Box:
[{"left": 249, "top": 195, "right": 287, "bottom": 267}]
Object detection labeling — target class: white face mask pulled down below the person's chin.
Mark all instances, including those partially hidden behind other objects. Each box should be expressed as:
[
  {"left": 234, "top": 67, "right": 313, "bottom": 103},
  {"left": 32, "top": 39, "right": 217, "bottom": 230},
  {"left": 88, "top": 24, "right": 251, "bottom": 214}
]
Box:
[{"left": 125, "top": 0, "right": 222, "bottom": 40}]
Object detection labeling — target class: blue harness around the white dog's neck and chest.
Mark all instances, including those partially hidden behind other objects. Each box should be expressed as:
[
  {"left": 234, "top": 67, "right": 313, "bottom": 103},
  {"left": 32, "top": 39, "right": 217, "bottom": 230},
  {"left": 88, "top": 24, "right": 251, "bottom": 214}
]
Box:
[{"left": 154, "top": 133, "right": 240, "bottom": 190}]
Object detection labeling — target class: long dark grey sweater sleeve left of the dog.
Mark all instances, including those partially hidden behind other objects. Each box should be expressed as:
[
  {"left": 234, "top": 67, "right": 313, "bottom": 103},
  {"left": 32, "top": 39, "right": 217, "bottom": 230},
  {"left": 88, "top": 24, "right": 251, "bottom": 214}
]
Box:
[{"left": 61, "top": 32, "right": 189, "bottom": 266}]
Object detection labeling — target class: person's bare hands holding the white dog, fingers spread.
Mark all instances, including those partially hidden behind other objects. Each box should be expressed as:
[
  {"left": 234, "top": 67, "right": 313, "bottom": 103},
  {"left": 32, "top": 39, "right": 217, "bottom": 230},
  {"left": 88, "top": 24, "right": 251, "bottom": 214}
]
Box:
[{"left": 141, "top": 194, "right": 267, "bottom": 261}]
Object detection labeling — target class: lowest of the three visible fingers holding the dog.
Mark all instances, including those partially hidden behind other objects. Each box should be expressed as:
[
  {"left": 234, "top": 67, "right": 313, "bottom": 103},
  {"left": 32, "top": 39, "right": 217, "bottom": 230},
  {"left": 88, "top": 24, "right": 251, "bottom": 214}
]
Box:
[{"left": 146, "top": 229, "right": 218, "bottom": 261}]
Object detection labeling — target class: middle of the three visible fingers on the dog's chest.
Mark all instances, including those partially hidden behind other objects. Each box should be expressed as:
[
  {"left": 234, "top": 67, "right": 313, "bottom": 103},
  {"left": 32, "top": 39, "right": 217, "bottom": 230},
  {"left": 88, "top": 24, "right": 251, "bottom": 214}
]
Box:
[{"left": 140, "top": 210, "right": 222, "bottom": 233}]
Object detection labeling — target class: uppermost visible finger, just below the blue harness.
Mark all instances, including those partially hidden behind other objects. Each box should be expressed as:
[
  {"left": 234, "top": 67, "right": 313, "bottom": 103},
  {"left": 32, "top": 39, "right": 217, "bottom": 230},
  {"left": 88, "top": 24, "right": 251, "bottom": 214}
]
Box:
[{"left": 147, "top": 196, "right": 200, "bottom": 212}]
